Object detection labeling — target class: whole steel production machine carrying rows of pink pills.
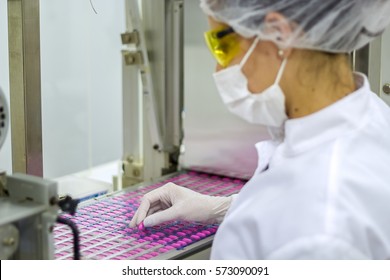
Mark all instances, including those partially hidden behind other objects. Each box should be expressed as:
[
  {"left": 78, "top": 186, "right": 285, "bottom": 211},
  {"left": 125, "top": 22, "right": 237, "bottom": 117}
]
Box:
[{"left": 0, "top": 0, "right": 390, "bottom": 260}]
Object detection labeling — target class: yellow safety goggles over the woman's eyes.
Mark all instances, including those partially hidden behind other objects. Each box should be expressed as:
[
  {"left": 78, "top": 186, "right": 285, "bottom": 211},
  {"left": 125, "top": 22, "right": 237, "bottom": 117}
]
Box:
[{"left": 204, "top": 27, "right": 240, "bottom": 67}]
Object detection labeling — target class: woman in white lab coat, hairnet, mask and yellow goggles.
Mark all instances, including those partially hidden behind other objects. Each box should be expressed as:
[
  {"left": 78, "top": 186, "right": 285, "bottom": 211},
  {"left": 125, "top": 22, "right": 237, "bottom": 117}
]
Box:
[{"left": 130, "top": 0, "right": 390, "bottom": 260}]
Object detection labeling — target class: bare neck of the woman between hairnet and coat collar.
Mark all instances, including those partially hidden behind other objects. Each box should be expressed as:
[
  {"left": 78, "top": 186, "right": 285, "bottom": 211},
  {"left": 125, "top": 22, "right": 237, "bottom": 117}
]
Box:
[{"left": 281, "top": 50, "right": 355, "bottom": 119}]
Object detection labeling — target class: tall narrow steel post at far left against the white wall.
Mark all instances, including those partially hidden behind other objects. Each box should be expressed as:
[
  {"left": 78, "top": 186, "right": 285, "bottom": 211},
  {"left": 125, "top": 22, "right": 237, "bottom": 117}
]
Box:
[{"left": 8, "top": 0, "right": 43, "bottom": 176}]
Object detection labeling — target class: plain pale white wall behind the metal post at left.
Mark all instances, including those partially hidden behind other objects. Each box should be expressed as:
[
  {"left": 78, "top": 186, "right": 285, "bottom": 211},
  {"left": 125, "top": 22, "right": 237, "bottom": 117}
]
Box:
[{"left": 0, "top": 0, "right": 125, "bottom": 178}]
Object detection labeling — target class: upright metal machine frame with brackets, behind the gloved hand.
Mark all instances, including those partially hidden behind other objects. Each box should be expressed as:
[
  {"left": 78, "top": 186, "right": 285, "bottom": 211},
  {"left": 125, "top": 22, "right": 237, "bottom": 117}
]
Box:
[{"left": 121, "top": 0, "right": 183, "bottom": 186}]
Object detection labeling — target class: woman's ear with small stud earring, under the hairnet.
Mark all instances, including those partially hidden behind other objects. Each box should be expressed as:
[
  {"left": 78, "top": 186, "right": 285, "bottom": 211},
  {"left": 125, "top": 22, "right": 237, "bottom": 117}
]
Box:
[{"left": 264, "top": 12, "right": 293, "bottom": 56}]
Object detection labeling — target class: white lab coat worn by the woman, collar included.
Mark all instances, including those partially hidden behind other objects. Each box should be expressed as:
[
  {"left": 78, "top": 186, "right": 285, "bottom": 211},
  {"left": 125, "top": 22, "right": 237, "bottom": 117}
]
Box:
[{"left": 211, "top": 74, "right": 390, "bottom": 259}]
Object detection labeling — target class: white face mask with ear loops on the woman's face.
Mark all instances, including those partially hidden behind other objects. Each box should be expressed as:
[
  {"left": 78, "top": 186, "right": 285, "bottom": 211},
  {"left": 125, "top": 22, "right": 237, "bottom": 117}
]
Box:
[{"left": 213, "top": 38, "right": 287, "bottom": 127}]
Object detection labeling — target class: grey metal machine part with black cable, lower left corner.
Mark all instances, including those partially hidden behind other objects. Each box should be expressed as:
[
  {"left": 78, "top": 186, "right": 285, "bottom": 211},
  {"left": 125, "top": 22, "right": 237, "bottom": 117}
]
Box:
[{"left": 0, "top": 88, "right": 79, "bottom": 260}]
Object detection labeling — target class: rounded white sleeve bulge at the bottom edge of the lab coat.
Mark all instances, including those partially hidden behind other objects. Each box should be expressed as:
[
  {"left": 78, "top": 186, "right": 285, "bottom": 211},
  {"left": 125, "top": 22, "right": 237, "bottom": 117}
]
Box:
[{"left": 267, "top": 235, "right": 369, "bottom": 260}]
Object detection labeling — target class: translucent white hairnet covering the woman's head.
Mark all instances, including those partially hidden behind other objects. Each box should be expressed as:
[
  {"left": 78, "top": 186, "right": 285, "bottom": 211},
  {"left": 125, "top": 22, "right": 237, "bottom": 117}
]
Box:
[{"left": 200, "top": 0, "right": 390, "bottom": 53}]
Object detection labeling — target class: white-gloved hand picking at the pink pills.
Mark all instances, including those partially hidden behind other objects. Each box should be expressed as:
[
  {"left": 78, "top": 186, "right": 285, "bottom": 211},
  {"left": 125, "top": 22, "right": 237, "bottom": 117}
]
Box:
[{"left": 130, "top": 183, "right": 232, "bottom": 227}]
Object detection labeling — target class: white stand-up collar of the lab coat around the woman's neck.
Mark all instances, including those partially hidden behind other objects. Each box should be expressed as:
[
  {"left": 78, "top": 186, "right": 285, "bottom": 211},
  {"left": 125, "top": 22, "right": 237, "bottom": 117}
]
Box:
[{"left": 283, "top": 73, "right": 371, "bottom": 155}]
